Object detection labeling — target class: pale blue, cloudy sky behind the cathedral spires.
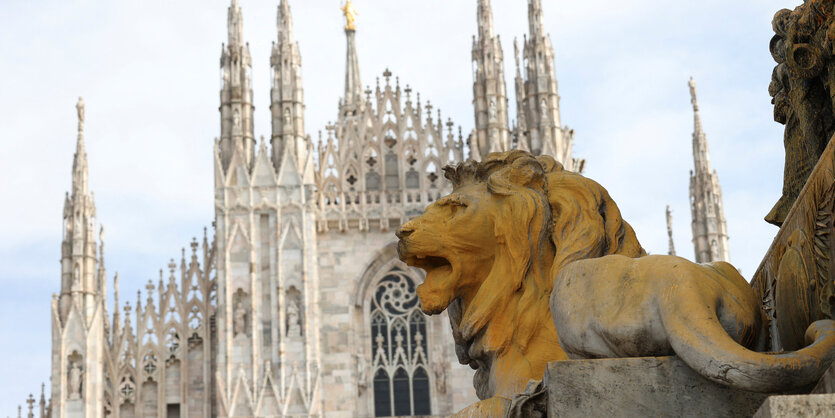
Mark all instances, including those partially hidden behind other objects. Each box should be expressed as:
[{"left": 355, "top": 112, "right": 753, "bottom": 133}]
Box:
[{"left": 0, "top": 0, "right": 800, "bottom": 416}]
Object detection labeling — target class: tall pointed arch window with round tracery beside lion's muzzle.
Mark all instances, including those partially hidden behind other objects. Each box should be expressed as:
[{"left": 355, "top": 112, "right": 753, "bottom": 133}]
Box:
[{"left": 369, "top": 267, "right": 431, "bottom": 417}]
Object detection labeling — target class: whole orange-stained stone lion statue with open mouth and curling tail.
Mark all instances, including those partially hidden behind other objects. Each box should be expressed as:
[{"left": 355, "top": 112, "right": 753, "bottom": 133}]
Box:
[{"left": 396, "top": 151, "right": 835, "bottom": 416}]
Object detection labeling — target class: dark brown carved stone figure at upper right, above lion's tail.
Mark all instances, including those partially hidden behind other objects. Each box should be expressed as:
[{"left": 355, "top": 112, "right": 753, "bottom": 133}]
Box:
[{"left": 765, "top": 1, "right": 835, "bottom": 226}]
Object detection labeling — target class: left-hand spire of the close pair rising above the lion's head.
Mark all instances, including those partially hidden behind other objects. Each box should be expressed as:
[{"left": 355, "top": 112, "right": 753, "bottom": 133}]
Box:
[{"left": 470, "top": 0, "right": 510, "bottom": 158}]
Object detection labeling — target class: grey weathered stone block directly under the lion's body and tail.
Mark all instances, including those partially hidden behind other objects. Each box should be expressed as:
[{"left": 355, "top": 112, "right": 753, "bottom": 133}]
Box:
[{"left": 543, "top": 356, "right": 768, "bottom": 418}]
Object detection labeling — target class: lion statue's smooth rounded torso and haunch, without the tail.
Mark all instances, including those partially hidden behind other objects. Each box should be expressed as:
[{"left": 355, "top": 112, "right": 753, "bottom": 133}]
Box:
[{"left": 551, "top": 255, "right": 763, "bottom": 358}]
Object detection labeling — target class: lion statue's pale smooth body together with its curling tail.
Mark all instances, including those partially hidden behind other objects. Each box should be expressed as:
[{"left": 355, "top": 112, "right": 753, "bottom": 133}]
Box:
[{"left": 551, "top": 255, "right": 835, "bottom": 392}]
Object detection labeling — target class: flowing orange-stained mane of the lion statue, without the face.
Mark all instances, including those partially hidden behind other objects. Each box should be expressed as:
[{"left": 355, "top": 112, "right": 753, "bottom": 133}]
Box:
[{"left": 444, "top": 151, "right": 646, "bottom": 363}]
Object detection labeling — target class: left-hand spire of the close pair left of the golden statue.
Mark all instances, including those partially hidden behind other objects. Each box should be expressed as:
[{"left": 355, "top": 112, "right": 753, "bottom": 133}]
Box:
[{"left": 220, "top": 0, "right": 255, "bottom": 170}]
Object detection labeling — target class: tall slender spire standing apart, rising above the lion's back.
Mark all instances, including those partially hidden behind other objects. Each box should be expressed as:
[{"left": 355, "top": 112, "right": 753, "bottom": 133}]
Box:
[{"left": 688, "top": 77, "right": 730, "bottom": 263}]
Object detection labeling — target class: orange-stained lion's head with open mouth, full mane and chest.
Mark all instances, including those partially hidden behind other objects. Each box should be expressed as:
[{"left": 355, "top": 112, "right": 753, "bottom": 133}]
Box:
[{"left": 397, "top": 151, "right": 644, "bottom": 397}]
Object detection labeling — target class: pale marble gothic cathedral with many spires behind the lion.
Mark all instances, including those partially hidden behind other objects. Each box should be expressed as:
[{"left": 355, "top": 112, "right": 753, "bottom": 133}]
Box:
[{"left": 36, "top": 0, "right": 727, "bottom": 418}]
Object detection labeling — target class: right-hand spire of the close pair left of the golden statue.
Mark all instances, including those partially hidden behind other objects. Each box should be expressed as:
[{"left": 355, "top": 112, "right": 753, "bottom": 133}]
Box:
[{"left": 270, "top": 0, "right": 307, "bottom": 171}]
